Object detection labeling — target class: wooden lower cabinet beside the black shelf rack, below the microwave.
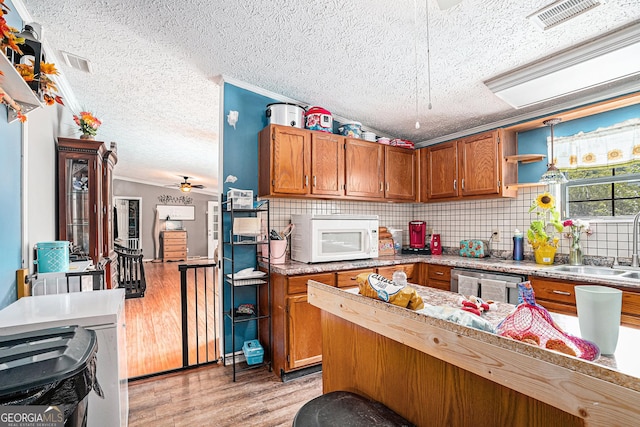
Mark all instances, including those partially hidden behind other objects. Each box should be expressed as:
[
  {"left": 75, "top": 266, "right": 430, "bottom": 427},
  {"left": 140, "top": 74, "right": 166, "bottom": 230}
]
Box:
[{"left": 268, "top": 273, "right": 336, "bottom": 378}]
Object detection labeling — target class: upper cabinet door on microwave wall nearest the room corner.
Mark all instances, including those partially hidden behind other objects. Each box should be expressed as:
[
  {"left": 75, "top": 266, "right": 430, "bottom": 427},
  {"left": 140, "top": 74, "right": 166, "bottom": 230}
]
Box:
[{"left": 384, "top": 145, "right": 416, "bottom": 200}]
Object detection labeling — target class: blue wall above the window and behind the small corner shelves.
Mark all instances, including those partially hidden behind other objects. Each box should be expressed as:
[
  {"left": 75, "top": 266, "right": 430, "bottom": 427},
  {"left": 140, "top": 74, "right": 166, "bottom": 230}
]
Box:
[{"left": 518, "top": 104, "right": 640, "bottom": 183}]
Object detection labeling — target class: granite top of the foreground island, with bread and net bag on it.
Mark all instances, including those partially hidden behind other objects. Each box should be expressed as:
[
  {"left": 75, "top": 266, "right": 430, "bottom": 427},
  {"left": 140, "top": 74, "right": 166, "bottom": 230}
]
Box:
[{"left": 309, "top": 282, "right": 640, "bottom": 391}]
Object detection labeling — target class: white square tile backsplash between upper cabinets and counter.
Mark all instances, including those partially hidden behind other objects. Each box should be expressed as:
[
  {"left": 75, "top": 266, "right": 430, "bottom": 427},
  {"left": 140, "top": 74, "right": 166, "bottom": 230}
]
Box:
[{"left": 271, "top": 188, "right": 633, "bottom": 259}]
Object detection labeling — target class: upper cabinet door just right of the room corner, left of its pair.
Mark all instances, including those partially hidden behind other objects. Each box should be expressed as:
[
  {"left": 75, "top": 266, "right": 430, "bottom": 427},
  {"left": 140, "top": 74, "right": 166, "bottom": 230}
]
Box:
[{"left": 427, "top": 141, "right": 458, "bottom": 199}]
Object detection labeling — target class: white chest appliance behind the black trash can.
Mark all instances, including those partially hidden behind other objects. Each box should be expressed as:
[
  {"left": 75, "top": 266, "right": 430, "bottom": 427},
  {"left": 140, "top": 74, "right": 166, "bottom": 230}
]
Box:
[{"left": 0, "top": 289, "right": 129, "bottom": 427}]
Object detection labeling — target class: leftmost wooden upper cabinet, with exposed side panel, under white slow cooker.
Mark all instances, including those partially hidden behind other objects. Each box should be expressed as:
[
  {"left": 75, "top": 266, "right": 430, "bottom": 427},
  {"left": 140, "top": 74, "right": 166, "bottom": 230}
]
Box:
[{"left": 258, "top": 125, "right": 311, "bottom": 196}]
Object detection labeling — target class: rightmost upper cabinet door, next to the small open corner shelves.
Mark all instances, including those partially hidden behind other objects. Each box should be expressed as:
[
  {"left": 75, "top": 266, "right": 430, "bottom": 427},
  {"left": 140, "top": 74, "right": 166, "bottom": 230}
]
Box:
[{"left": 458, "top": 132, "right": 501, "bottom": 196}]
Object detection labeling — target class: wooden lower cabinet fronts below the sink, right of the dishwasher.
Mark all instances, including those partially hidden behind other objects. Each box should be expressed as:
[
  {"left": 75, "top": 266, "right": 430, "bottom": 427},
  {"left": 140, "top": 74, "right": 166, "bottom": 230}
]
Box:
[{"left": 529, "top": 276, "right": 640, "bottom": 327}]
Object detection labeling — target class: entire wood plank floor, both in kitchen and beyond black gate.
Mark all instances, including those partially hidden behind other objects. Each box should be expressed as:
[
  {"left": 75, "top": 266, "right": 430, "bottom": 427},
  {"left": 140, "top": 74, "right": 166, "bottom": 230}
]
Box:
[{"left": 125, "top": 262, "right": 322, "bottom": 427}]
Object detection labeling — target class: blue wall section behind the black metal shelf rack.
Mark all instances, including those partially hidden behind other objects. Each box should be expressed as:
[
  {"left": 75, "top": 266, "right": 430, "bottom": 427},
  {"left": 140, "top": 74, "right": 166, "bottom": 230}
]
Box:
[{"left": 222, "top": 83, "right": 277, "bottom": 353}]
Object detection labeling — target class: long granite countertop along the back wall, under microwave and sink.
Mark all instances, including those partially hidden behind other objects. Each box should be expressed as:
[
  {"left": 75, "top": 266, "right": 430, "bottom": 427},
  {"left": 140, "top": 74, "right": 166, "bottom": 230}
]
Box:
[{"left": 260, "top": 254, "right": 640, "bottom": 291}]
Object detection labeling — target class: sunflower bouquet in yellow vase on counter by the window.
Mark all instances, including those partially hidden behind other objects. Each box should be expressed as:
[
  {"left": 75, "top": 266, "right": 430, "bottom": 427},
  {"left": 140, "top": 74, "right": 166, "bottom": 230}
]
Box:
[{"left": 527, "top": 192, "right": 563, "bottom": 264}]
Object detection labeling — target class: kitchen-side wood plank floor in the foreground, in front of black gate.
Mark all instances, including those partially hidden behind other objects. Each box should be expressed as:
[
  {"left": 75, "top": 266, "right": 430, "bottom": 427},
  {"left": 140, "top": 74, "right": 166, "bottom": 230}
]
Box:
[{"left": 129, "top": 365, "right": 322, "bottom": 427}]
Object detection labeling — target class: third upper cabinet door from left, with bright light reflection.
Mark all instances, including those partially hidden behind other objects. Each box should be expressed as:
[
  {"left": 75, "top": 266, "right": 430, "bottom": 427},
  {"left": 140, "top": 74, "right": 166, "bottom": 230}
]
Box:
[{"left": 345, "top": 138, "right": 384, "bottom": 199}]
